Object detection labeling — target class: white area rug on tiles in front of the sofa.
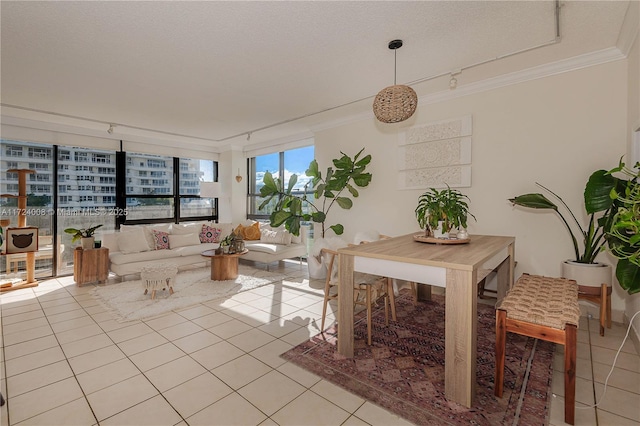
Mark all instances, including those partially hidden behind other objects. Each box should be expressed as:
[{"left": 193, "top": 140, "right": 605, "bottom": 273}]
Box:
[{"left": 91, "top": 264, "right": 286, "bottom": 322}]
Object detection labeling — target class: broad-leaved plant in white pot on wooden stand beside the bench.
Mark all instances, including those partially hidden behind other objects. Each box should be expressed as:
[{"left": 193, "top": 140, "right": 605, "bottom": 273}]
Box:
[{"left": 509, "top": 178, "right": 612, "bottom": 293}]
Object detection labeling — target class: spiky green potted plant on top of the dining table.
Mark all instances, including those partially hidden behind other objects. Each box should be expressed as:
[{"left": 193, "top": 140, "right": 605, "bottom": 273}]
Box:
[{"left": 415, "top": 185, "right": 476, "bottom": 238}]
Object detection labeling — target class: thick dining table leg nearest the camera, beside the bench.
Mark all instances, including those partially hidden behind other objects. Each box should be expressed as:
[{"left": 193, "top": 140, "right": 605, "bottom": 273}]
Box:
[{"left": 444, "top": 269, "right": 478, "bottom": 407}]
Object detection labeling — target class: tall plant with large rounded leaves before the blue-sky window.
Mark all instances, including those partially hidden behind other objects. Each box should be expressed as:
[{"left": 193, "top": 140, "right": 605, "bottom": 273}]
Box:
[{"left": 259, "top": 148, "right": 371, "bottom": 238}]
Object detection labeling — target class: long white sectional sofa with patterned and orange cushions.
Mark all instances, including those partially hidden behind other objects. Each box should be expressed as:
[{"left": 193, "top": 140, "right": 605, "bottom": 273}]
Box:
[{"left": 100, "top": 222, "right": 308, "bottom": 276}]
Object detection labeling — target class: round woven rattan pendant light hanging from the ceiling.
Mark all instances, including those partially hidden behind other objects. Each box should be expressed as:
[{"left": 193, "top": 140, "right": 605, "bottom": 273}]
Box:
[{"left": 373, "top": 40, "right": 418, "bottom": 123}]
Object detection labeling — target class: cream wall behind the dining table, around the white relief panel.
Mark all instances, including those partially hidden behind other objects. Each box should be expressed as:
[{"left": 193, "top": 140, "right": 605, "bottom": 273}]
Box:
[{"left": 315, "top": 60, "right": 628, "bottom": 321}]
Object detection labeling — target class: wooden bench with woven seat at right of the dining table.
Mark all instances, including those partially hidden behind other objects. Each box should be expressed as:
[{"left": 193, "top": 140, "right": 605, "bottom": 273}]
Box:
[{"left": 494, "top": 274, "right": 580, "bottom": 424}]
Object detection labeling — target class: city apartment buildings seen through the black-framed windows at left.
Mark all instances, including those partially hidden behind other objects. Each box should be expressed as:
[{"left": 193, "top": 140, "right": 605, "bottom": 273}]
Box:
[{"left": 0, "top": 139, "right": 214, "bottom": 276}]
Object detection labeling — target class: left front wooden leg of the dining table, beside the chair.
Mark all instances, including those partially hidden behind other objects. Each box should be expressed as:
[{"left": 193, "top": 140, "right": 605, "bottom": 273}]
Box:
[{"left": 338, "top": 253, "right": 353, "bottom": 358}]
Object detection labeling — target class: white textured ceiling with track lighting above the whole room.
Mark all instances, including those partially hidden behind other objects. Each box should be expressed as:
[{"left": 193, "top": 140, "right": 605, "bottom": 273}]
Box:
[{"left": 0, "top": 0, "right": 637, "bottom": 152}]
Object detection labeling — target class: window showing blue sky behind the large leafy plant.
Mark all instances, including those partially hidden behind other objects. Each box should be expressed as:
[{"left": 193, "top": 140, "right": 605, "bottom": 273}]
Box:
[{"left": 247, "top": 146, "right": 314, "bottom": 219}]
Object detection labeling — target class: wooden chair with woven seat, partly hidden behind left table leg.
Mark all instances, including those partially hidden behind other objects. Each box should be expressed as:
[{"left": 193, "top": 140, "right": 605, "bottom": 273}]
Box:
[{"left": 320, "top": 248, "right": 395, "bottom": 345}]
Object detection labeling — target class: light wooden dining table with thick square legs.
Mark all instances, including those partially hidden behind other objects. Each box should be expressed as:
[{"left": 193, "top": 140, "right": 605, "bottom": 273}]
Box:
[{"left": 338, "top": 233, "right": 515, "bottom": 407}]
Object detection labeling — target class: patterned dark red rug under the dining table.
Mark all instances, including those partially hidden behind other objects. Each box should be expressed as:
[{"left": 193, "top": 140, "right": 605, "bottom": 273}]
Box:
[{"left": 281, "top": 290, "right": 554, "bottom": 425}]
